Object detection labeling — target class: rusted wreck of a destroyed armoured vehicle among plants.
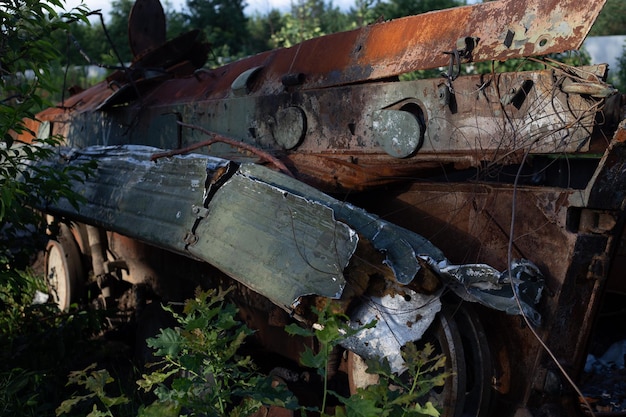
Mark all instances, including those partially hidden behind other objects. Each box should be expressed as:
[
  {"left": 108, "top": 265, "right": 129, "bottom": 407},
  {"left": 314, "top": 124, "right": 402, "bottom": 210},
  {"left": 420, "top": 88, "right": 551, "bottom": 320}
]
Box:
[{"left": 22, "top": 0, "right": 626, "bottom": 417}]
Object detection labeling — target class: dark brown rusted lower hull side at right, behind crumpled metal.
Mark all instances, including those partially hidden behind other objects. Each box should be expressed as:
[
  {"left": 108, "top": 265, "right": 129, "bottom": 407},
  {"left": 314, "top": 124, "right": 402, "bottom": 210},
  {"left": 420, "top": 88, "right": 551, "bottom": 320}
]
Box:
[{"left": 348, "top": 119, "right": 626, "bottom": 406}]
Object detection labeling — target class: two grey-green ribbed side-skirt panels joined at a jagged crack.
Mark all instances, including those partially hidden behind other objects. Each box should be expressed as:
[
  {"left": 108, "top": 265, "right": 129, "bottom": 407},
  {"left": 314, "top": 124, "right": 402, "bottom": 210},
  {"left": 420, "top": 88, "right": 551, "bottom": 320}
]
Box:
[{"left": 41, "top": 145, "right": 358, "bottom": 309}]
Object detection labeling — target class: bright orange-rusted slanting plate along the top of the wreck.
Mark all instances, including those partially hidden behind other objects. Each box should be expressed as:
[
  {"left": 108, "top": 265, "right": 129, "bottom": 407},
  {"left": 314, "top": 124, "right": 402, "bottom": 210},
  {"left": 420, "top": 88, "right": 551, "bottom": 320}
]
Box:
[{"left": 139, "top": 0, "right": 604, "bottom": 97}]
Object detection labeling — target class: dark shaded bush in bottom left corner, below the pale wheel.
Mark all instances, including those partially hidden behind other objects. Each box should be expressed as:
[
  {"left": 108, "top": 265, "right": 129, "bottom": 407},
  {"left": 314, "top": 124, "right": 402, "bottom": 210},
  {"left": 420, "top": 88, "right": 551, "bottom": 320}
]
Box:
[{"left": 0, "top": 271, "right": 108, "bottom": 417}]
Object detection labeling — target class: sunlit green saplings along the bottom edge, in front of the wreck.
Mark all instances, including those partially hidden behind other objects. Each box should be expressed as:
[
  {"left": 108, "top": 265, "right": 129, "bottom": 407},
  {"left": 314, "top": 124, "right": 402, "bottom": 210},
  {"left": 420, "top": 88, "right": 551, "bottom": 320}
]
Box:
[{"left": 56, "top": 290, "right": 448, "bottom": 417}]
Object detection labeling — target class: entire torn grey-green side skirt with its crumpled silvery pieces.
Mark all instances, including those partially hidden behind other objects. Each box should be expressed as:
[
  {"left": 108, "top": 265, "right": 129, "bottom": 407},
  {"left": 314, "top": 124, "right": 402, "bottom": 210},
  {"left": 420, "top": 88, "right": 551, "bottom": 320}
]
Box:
[{"left": 39, "top": 145, "right": 544, "bottom": 370}]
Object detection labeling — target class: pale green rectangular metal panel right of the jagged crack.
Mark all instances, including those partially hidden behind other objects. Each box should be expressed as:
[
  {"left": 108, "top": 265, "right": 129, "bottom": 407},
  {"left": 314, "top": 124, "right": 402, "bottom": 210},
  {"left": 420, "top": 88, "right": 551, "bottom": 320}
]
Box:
[{"left": 187, "top": 165, "right": 358, "bottom": 309}]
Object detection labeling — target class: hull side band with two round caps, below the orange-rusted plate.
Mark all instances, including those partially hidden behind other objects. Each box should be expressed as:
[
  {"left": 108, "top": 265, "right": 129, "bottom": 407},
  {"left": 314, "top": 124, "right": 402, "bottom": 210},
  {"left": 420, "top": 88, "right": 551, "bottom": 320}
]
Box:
[{"left": 40, "top": 66, "right": 606, "bottom": 190}]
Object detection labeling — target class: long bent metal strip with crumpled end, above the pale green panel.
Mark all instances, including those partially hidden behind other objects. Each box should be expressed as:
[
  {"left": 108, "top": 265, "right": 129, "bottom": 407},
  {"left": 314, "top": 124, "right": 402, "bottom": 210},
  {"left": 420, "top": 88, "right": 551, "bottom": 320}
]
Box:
[{"left": 232, "top": 164, "right": 544, "bottom": 325}]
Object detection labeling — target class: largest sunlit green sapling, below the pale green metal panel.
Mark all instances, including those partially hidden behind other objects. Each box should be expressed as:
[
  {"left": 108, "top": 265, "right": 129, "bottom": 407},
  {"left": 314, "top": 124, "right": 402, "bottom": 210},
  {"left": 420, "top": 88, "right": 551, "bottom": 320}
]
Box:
[{"left": 132, "top": 290, "right": 295, "bottom": 416}]
